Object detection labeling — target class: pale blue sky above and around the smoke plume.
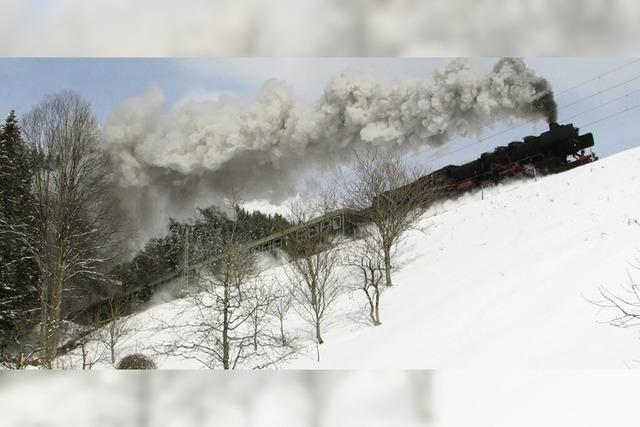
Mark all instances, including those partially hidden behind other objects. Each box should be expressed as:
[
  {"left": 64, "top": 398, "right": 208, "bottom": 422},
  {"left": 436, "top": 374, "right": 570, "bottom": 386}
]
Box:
[{"left": 0, "top": 58, "right": 640, "bottom": 171}]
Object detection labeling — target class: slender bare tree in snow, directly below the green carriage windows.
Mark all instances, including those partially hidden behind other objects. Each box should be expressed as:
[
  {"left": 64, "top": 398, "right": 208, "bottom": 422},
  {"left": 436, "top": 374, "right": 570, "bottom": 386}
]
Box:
[{"left": 285, "top": 198, "right": 340, "bottom": 360}]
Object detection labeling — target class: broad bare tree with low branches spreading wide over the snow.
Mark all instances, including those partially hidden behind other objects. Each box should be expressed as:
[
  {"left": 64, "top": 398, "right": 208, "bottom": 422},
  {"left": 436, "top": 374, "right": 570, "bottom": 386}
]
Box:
[{"left": 162, "top": 196, "right": 292, "bottom": 369}]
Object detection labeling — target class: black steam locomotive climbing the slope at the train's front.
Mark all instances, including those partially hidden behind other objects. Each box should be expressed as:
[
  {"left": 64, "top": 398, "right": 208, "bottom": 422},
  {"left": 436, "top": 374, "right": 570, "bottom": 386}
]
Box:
[{"left": 419, "top": 123, "right": 597, "bottom": 193}]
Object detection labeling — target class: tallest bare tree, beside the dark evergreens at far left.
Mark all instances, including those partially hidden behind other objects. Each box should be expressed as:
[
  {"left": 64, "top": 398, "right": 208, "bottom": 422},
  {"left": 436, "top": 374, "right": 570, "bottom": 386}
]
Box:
[{"left": 16, "top": 92, "right": 127, "bottom": 368}]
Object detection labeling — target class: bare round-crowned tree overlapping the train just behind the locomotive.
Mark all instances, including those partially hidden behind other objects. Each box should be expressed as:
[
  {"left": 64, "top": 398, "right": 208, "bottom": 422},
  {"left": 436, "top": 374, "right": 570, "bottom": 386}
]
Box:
[{"left": 339, "top": 152, "right": 445, "bottom": 286}]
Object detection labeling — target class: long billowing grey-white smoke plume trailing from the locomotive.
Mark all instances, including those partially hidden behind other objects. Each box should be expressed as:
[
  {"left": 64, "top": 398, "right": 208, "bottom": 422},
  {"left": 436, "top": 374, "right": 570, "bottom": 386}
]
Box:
[{"left": 105, "top": 58, "right": 556, "bottom": 236}]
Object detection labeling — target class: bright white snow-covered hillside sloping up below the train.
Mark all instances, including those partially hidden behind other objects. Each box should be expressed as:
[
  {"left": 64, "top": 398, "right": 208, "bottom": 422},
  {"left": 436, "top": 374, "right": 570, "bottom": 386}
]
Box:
[{"left": 62, "top": 149, "right": 640, "bottom": 369}]
